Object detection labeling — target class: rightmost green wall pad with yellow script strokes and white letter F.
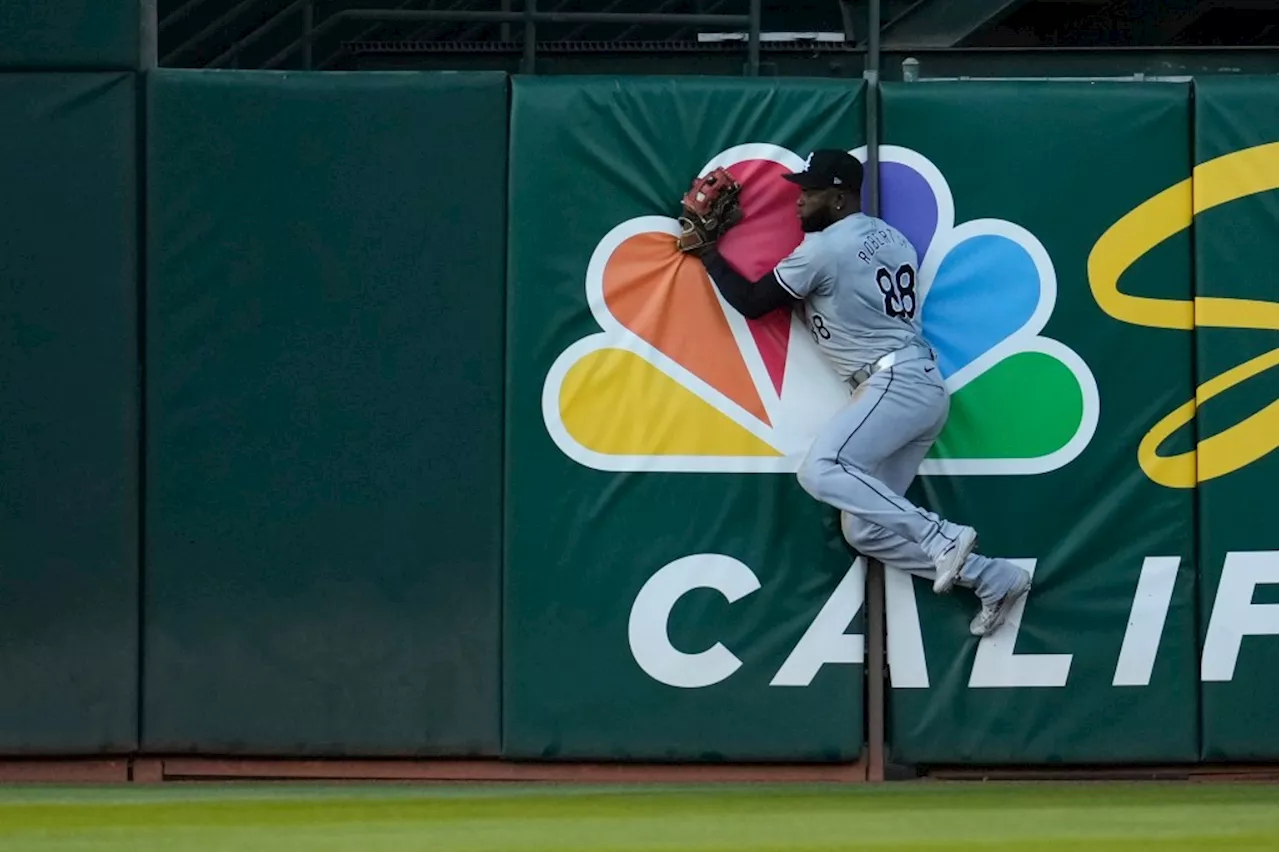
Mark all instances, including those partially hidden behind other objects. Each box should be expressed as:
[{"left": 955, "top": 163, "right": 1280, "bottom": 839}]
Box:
[{"left": 1192, "top": 77, "right": 1280, "bottom": 760}]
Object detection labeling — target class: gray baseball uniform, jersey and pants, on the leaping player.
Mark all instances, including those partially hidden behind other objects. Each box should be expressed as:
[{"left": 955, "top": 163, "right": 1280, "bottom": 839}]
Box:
[{"left": 774, "top": 212, "right": 1020, "bottom": 603}]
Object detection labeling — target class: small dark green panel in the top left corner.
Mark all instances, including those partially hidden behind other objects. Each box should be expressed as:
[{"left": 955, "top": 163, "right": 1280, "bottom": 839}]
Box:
[{"left": 0, "top": 0, "right": 145, "bottom": 70}]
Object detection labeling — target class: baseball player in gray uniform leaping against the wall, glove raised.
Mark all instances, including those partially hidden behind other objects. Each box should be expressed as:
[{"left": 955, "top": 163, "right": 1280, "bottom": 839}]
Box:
[{"left": 681, "top": 150, "right": 1030, "bottom": 636}]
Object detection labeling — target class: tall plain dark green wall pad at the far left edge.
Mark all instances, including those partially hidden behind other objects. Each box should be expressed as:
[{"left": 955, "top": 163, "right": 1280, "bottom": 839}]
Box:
[{"left": 0, "top": 73, "right": 140, "bottom": 753}]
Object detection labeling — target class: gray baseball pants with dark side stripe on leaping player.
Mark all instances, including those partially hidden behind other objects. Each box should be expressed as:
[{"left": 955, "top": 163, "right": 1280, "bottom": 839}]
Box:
[{"left": 797, "top": 358, "right": 1020, "bottom": 604}]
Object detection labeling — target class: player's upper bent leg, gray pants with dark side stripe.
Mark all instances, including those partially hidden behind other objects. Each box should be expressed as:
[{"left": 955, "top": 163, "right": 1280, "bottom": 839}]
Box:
[{"left": 797, "top": 359, "right": 977, "bottom": 578}]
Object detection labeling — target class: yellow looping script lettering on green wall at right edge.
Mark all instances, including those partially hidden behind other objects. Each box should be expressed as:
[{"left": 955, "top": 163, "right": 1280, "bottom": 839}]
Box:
[{"left": 1089, "top": 142, "right": 1280, "bottom": 489}]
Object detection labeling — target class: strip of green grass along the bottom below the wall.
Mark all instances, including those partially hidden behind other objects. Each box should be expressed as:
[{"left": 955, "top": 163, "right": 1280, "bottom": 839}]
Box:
[{"left": 0, "top": 782, "right": 1280, "bottom": 852}]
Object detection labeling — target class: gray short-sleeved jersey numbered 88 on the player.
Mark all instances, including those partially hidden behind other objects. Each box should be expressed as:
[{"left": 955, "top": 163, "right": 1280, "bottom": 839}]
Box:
[{"left": 773, "top": 212, "right": 928, "bottom": 379}]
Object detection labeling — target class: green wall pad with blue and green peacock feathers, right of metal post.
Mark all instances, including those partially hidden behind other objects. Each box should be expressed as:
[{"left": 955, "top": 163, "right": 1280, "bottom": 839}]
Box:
[{"left": 881, "top": 82, "right": 1198, "bottom": 764}]
